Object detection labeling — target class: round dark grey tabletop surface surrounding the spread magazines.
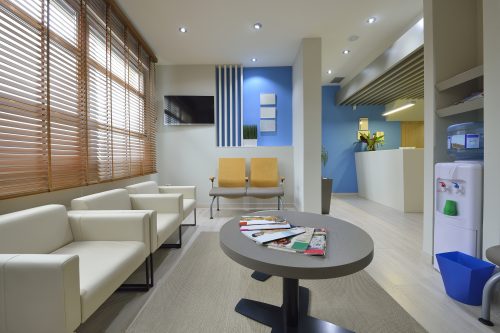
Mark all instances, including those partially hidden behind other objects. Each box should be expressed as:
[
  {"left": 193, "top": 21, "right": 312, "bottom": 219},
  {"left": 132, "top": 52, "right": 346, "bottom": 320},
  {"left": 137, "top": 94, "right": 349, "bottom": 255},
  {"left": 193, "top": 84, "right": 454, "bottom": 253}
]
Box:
[{"left": 219, "top": 210, "right": 373, "bottom": 279}]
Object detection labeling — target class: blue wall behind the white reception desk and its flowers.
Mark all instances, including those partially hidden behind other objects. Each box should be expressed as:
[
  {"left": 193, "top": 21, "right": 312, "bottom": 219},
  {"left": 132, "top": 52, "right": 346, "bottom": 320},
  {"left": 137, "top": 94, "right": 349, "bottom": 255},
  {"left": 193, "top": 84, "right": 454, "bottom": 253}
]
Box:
[{"left": 322, "top": 86, "right": 401, "bottom": 193}]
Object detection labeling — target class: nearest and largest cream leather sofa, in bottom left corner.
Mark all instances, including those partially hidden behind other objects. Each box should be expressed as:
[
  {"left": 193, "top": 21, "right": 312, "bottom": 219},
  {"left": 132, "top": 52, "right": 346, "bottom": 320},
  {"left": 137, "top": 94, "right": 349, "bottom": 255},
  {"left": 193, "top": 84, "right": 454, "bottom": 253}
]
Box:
[{"left": 0, "top": 205, "right": 150, "bottom": 333}]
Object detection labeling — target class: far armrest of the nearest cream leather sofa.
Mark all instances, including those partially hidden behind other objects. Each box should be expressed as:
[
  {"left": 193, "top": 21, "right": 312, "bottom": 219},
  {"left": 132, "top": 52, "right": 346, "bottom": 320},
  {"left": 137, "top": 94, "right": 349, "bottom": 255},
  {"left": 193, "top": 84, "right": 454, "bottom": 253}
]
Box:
[{"left": 68, "top": 210, "right": 151, "bottom": 256}]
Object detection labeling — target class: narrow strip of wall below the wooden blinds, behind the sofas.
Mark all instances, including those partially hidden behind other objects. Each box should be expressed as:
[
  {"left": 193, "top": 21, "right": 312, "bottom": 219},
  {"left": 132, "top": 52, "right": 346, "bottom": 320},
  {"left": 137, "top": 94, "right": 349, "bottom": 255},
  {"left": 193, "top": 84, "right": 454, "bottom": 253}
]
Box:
[{"left": 0, "top": 174, "right": 158, "bottom": 214}]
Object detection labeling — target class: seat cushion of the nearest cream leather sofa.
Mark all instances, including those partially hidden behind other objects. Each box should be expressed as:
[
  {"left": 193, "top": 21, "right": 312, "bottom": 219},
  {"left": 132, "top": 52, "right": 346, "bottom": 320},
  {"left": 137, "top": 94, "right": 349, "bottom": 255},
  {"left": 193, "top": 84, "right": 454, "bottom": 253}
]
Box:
[{"left": 53, "top": 241, "right": 145, "bottom": 322}]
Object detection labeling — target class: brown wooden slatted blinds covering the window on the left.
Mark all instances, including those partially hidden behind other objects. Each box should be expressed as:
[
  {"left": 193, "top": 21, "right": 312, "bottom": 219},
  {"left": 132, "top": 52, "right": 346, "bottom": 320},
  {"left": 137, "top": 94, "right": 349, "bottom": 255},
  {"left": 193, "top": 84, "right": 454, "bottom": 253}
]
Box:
[{"left": 0, "top": 0, "right": 156, "bottom": 198}]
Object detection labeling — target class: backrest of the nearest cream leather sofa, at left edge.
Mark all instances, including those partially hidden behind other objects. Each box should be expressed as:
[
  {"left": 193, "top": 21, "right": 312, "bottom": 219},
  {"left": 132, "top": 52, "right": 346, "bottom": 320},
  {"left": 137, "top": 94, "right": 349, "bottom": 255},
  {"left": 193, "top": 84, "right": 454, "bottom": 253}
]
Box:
[{"left": 0, "top": 205, "right": 73, "bottom": 254}]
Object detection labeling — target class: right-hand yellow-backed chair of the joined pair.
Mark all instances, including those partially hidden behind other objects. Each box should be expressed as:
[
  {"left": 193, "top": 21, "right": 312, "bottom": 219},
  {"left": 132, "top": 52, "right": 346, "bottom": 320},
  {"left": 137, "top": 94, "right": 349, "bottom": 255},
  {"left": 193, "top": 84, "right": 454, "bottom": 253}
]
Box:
[{"left": 246, "top": 157, "right": 285, "bottom": 210}]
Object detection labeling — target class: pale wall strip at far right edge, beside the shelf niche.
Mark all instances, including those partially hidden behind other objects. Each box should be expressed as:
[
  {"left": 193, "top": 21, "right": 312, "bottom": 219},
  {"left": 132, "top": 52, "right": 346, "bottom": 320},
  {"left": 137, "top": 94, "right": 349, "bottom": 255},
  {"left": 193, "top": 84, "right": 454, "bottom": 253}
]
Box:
[{"left": 483, "top": 0, "right": 500, "bottom": 255}]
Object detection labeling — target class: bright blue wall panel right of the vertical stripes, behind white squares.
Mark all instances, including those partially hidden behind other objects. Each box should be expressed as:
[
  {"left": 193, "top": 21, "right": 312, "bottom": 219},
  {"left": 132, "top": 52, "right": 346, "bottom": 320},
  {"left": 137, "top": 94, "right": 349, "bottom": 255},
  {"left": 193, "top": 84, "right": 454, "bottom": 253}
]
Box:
[{"left": 243, "top": 66, "right": 293, "bottom": 146}]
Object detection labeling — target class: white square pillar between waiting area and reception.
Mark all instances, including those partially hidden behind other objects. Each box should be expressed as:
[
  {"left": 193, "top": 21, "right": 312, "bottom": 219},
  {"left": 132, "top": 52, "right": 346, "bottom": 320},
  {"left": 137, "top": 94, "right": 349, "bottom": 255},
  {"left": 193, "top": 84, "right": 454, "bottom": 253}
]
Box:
[{"left": 292, "top": 38, "right": 321, "bottom": 213}]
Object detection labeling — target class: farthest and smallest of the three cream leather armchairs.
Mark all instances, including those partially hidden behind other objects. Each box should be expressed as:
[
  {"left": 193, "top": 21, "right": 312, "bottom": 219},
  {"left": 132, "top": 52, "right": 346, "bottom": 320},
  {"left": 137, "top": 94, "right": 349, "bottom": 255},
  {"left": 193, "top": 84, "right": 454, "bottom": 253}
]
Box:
[{"left": 125, "top": 181, "right": 196, "bottom": 226}]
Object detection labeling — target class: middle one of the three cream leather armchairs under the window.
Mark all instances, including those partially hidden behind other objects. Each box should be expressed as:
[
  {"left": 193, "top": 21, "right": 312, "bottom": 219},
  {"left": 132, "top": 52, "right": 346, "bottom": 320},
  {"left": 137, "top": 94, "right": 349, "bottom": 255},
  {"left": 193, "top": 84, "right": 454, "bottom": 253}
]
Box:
[{"left": 71, "top": 189, "right": 183, "bottom": 253}]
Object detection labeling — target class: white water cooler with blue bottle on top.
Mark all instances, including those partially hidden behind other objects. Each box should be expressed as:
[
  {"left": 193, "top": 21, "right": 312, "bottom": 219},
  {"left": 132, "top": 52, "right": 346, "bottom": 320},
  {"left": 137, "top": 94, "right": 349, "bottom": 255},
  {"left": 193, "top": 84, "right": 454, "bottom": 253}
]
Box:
[{"left": 434, "top": 122, "right": 484, "bottom": 270}]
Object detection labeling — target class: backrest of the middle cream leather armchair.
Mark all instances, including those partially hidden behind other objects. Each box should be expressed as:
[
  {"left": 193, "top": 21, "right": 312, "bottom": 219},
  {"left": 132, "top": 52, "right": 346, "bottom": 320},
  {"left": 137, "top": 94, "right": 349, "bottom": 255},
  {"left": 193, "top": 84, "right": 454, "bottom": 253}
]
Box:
[{"left": 71, "top": 188, "right": 132, "bottom": 210}]
